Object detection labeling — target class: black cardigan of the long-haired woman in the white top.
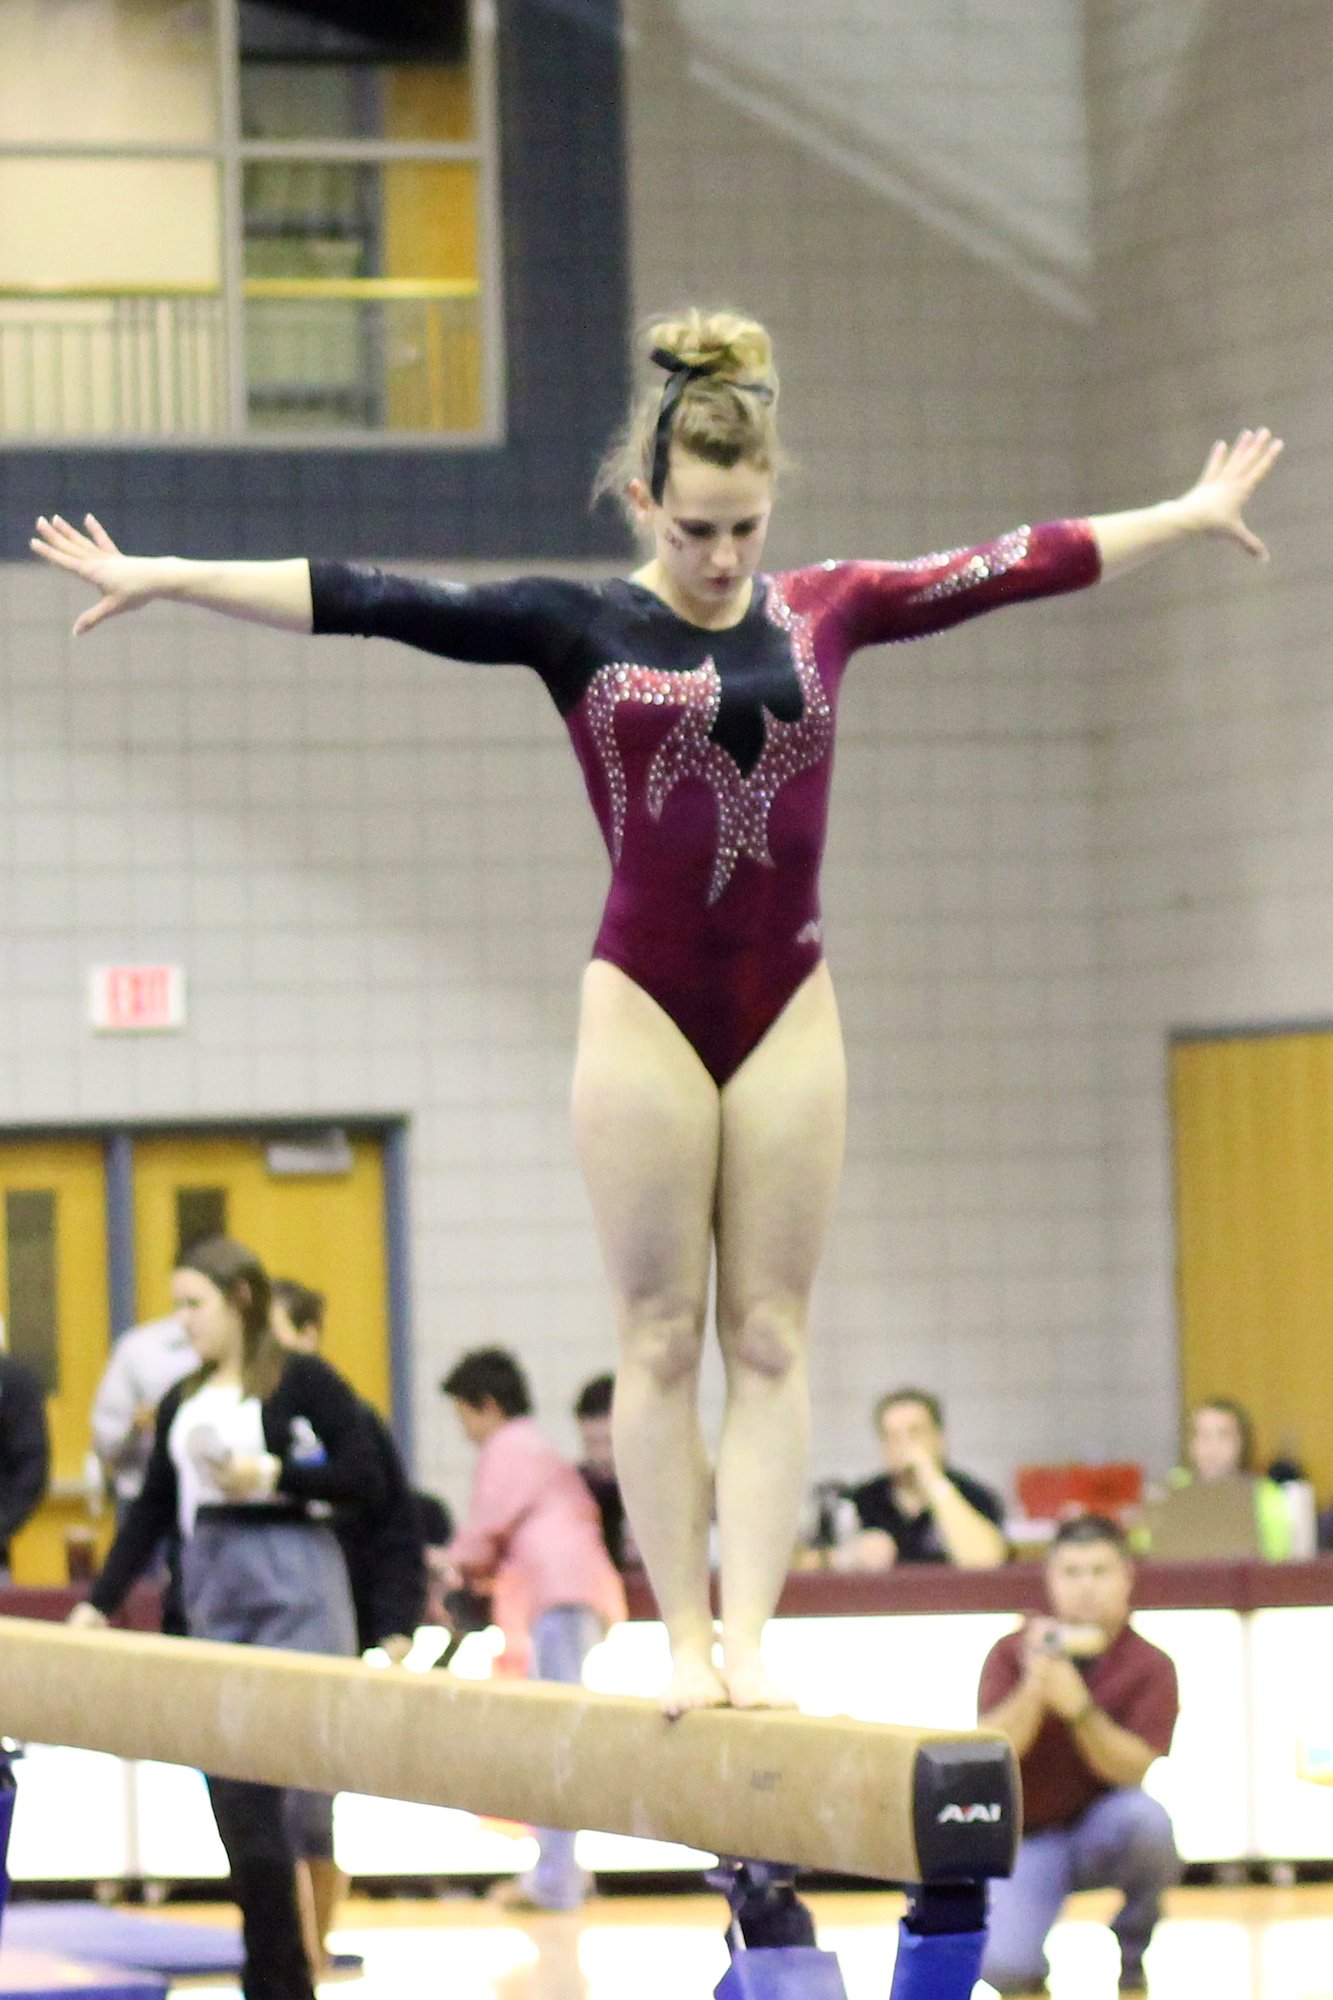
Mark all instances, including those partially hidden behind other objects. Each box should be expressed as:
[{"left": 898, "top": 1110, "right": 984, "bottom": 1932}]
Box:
[{"left": 88, "top": 1354, "right": 384, "bottom": 1616}]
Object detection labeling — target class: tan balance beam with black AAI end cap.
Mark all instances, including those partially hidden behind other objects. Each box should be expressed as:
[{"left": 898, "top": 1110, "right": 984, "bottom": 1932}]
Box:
[{"left": 0, "top": 1618, "right": 1019, "bottom": 1882}]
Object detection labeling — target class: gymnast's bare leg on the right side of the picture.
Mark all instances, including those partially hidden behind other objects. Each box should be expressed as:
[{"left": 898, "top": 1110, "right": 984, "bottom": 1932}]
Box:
[{"left": 717, "top": 966, "right": 847, "bottom": 1708}]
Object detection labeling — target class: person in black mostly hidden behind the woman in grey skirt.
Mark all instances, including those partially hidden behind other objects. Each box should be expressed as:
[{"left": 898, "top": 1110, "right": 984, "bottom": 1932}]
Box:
[{"left": 270, "top": 1278, "right": 426, "bottom": 1980}]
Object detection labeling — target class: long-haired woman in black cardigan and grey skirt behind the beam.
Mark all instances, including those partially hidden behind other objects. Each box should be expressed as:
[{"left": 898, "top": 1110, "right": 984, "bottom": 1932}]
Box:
[{"left": 70, "top": 1236, "right": 384, "bottom": 2000}]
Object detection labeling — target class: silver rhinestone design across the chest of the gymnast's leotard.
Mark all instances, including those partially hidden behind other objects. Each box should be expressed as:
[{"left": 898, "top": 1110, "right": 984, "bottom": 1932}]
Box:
[{"left": 584, "top": 582, "right": 833, "bottom": 904}]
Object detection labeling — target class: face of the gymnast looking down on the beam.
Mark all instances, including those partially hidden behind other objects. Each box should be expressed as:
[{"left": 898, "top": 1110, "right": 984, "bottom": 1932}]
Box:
[{"left": 630, "top": 450, "right": 773, "bottom": 626}]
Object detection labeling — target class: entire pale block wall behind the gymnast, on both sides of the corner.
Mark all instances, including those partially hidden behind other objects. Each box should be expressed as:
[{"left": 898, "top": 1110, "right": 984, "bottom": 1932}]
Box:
[{"left": 0, "top": 0, "right": 1333, "bottom": 1496}]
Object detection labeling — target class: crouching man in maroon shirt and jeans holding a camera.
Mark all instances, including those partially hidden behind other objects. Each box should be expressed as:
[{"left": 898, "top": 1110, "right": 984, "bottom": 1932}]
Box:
[{"left": 977, "top": 1514, "right": 1181, "bottom": 1994}]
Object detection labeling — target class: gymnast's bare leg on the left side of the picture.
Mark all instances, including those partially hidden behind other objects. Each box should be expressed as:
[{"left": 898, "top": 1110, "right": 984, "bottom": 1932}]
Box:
[{"left": 574, "top": 958, "right": 727, "bottom": 1714}]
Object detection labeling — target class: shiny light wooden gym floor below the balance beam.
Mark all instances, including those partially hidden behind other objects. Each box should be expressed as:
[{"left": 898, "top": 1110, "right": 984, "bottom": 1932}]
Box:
[{"left": 162, "top": 1886, "right": 1333, "bottom": 2000}]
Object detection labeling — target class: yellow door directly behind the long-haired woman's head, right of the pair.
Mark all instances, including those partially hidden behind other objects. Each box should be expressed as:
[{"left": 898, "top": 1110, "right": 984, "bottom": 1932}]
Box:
[{"left": 134, "top": 1136, "right": 390, "bottom": 1414}]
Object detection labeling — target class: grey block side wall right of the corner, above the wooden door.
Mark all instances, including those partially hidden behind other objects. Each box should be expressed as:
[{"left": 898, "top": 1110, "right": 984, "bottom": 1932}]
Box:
[{"left": 1083, "top": 0, "right": 1333, "bottom": 1446}]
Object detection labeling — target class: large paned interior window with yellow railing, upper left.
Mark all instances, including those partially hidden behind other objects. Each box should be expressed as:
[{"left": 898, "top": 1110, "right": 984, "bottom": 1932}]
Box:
[{"left": 0, "top": 0, "right": 500, "bottom": 444}]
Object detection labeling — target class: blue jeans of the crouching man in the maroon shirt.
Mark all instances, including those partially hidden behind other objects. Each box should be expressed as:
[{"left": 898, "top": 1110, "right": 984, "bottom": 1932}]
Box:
[{"left": 981, "top": 1788, "right": 1181, "bottom": 1994}]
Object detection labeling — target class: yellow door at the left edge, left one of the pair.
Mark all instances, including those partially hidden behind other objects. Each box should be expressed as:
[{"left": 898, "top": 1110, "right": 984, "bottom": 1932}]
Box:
[{"left": 0, "top": 1138, "right": 110, "bottom": 1584}]
